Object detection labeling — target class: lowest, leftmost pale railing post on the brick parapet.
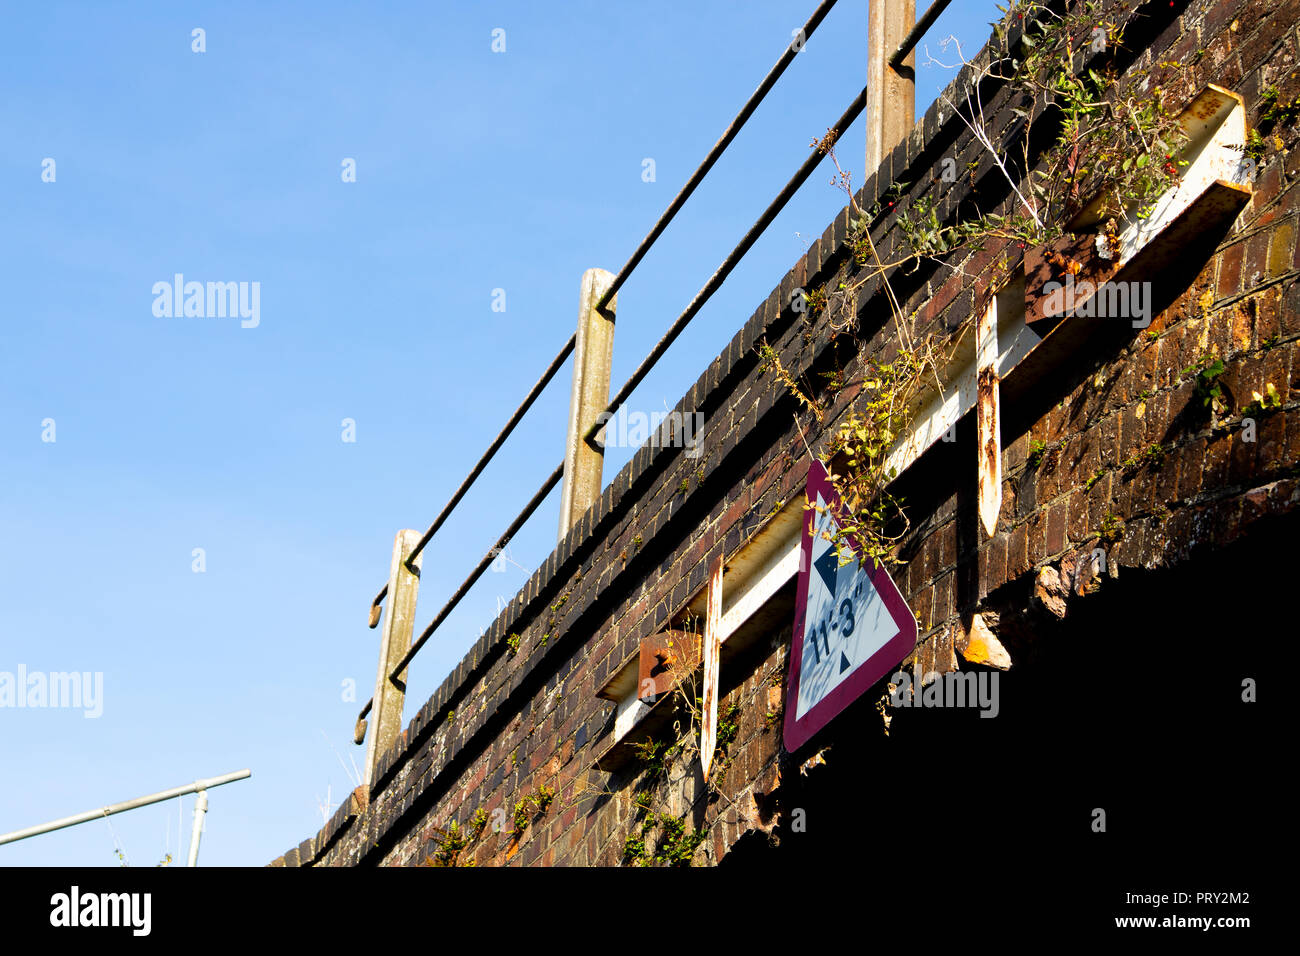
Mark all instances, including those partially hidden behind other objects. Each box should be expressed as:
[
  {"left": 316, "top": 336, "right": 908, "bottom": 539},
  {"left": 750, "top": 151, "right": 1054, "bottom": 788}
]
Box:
[{"left": 365, "top": 529, "right": 424, "bottom": 787}]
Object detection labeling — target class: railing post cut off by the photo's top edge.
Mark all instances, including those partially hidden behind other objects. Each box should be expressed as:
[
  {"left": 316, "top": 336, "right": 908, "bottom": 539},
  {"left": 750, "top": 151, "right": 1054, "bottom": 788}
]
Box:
[{"left": 859, "top": 0, "right": 917, "bottom": 178}]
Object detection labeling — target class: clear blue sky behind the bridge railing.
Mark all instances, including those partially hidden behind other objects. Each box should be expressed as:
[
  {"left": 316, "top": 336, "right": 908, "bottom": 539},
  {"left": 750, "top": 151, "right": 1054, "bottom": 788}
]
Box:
[{"left": 0, "top": 0, "right": 996, "bottom": 866}]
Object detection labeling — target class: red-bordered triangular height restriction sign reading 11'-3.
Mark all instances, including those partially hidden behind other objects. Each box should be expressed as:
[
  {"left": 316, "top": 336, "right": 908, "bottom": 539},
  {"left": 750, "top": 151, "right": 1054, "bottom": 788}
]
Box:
[{"left": 785, "top": 462, "right": 917, "bottom": 752}]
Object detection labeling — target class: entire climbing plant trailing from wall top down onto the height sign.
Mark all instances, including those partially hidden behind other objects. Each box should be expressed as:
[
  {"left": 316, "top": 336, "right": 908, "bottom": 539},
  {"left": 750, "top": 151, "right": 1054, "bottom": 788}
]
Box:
[{"left": 759, "top": 0, "right": 1206, "bottom": 572}]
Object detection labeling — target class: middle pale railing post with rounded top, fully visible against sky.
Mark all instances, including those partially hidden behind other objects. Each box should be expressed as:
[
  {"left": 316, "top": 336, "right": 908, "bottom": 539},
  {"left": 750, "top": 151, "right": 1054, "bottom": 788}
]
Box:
[{"left": 559, "top": 269, "right": 619, "bottom": 540}]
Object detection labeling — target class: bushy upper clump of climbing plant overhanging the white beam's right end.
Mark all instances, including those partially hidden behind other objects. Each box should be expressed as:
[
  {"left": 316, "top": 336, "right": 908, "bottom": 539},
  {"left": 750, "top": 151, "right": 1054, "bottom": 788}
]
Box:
[{"left": 898, "top": 0, "right": 1187, "bottom": 268}]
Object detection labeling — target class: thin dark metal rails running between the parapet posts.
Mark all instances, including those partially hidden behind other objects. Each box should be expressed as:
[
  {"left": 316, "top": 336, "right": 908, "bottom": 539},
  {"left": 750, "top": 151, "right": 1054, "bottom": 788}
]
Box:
[{"left": 358, "top": 0, "right": 952, "bottom": 743}]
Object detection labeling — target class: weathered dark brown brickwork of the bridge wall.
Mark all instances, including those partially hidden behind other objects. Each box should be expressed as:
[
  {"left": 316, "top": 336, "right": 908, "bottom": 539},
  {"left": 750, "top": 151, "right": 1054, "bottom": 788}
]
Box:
[{"left": 276, "top": 0, "right": 1300, "bottom": 866}]
